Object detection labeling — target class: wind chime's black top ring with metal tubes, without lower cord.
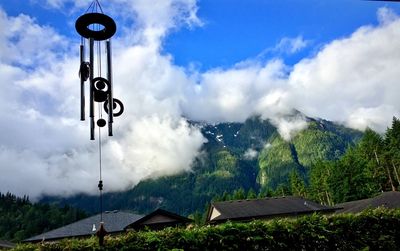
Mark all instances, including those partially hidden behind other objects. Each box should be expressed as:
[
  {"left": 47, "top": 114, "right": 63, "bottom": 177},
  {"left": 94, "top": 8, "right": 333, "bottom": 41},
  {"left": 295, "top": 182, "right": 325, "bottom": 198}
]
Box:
[{"left": 75, "top": 6, "right": 124, "bottom": 140}]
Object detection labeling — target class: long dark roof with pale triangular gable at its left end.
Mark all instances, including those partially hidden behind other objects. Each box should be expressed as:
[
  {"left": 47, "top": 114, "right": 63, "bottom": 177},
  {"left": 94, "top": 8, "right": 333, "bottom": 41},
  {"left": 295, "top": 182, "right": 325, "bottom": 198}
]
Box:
[{"left": 207, "top": 196, "right": 337, "bottom": 222}]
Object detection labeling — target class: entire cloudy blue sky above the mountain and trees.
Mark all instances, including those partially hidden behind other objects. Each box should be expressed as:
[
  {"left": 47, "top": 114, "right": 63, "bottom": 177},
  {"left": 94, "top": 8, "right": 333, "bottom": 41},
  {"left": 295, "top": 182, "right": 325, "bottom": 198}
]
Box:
[{"left": 0, "top": 0, "right": 400, "bottom": 198}]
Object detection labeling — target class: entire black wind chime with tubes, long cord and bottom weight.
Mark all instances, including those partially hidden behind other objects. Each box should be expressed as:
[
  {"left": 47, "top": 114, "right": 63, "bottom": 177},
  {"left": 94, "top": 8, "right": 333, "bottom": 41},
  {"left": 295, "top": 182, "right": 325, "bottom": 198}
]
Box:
[{"left": 75, "top": 0, "right": 124, "bottom": 246}]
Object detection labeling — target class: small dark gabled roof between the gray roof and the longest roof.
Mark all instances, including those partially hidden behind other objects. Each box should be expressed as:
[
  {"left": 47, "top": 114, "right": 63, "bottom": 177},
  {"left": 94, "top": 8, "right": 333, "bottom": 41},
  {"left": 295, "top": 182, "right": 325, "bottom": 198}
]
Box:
[{"left": 126, "top": 208, "right": 192, "bottom": 229}]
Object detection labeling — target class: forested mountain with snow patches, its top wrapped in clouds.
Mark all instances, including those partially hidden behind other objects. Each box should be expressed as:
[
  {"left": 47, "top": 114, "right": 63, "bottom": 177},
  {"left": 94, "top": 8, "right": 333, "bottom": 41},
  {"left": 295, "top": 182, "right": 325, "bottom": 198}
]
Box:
[{"left": 42, "top": 116, "right": 362, "bottom": 215}]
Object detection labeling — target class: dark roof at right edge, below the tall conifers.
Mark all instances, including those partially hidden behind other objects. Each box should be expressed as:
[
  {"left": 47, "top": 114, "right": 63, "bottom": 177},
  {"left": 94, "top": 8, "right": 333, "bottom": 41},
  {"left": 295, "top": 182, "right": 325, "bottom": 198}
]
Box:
[{"left": 337, "top": 191, "right": 400, "bottom": 213}]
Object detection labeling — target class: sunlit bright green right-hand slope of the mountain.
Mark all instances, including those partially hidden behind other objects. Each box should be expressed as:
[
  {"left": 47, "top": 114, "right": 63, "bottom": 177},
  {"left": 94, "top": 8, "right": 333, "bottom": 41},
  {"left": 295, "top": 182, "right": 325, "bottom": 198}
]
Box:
[{"left": 258, "top": 119, "right": 362, "bottom": 190}]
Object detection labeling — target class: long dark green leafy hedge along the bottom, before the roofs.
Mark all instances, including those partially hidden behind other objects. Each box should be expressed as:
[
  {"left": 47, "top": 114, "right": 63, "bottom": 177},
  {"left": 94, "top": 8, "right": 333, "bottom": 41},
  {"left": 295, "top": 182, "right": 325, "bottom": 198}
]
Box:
[{"left": 15, "top": 208, "right": 400, "bottom": 251}]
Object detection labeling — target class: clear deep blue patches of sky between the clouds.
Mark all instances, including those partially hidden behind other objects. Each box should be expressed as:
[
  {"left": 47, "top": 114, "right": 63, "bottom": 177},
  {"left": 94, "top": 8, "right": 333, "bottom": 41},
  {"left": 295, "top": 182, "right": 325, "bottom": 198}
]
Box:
[{"left": 0, "top": 0, "right": 400, "bottom": 70}]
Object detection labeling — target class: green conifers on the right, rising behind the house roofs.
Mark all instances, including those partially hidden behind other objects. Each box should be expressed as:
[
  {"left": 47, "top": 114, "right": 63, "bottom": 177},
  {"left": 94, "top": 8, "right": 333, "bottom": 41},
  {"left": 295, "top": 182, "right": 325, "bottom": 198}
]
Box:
[{"left": 214, "top": 117, "right": 400, "bottom": 205}]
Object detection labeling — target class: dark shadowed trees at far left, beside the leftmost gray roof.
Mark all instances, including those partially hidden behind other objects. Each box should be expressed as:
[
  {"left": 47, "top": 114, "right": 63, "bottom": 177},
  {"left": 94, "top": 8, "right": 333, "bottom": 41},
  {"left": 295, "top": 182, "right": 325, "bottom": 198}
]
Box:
[{"left": 0, "top": 193, "right": 86, "bottom": 242}]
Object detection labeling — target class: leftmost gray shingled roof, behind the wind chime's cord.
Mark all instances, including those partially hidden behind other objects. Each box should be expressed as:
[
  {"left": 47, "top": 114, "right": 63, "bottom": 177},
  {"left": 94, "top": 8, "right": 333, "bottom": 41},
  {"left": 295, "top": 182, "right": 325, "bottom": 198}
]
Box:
[{"left": 25, "top": 211, "right": 143, "bottom": 242}]
